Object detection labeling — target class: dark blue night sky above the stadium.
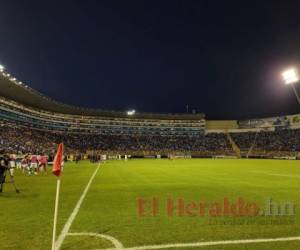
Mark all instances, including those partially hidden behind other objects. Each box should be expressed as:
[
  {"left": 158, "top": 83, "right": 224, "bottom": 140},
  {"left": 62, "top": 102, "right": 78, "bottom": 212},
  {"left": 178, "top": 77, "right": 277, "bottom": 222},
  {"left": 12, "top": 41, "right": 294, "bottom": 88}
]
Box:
[{"left": 0, "top": 0, "right": 300, "bottom": 119}]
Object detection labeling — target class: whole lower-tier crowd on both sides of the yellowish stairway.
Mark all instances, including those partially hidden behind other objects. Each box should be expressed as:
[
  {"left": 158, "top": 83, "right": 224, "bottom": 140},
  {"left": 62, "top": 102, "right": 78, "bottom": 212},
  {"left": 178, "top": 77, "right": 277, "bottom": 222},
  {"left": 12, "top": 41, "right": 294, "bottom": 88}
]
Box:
[{"left": 0, "top": 124, "right": 300, "bottom": 156}]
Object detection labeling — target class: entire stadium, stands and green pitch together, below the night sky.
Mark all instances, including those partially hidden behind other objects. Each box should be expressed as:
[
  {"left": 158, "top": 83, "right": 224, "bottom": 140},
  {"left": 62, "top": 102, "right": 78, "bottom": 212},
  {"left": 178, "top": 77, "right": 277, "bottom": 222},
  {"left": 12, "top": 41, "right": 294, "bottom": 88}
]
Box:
[{"left": 0, "top": 65, "right": 300, "bottom": 249}]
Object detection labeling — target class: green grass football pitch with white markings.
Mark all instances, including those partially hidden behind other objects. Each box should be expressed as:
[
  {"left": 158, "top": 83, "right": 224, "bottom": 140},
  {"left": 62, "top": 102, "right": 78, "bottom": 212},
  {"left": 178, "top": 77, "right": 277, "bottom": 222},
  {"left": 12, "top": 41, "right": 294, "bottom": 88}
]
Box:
[{"left": 0, "top": 159, "right": 300, "bottom": 250}]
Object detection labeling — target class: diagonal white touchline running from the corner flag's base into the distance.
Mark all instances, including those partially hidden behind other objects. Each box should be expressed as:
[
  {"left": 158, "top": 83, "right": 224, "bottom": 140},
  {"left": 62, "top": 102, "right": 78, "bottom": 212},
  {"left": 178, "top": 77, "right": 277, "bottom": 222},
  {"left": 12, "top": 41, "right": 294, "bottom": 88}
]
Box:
[{"left": 55, "top": 163, "right": 100, "bottom": 250}]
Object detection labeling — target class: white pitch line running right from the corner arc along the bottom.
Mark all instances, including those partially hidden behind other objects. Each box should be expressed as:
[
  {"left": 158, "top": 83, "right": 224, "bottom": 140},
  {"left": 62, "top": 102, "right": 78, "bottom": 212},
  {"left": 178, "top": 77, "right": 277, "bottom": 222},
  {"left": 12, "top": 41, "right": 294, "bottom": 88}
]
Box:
[{"left": 96, "top": 236, "right": 300, "bottom": 250}]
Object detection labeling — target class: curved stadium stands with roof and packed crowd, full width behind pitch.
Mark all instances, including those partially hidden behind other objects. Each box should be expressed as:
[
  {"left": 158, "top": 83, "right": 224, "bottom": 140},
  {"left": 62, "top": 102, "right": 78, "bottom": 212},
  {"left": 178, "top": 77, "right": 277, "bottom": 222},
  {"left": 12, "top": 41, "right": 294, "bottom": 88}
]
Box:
[{"left": 0, "top": 72, "right": 300, "bottom": 158}]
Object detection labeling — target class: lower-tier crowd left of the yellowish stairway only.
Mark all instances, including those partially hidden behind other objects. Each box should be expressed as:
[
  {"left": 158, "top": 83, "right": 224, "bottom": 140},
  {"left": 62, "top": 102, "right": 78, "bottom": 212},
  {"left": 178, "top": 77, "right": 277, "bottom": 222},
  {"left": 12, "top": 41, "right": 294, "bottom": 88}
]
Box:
[{"left": 0, "top": 125, "right": 233, "bottom": 155}]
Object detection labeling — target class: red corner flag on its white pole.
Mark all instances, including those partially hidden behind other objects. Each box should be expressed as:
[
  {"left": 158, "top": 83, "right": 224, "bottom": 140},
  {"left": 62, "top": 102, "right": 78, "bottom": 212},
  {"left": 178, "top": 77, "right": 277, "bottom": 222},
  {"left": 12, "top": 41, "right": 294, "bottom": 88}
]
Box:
[{"left": 52, "top": 143, "right": 64, "bottom": 250}]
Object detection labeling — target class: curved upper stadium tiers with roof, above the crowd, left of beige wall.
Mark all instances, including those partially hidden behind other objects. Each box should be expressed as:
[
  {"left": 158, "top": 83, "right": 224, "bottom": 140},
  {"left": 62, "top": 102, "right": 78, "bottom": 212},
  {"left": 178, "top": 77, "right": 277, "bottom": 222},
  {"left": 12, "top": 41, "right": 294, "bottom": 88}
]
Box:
[{"left": 0, "top": 73, "right": 205, "bottom": 136}]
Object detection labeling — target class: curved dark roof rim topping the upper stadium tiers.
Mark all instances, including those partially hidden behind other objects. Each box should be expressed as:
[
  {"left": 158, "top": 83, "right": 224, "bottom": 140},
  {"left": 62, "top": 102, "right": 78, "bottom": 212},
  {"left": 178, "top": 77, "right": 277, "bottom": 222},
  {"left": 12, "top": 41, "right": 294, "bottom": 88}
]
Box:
[{"left": 0, "top": 74, "right": 205, "bottom": 120}]
